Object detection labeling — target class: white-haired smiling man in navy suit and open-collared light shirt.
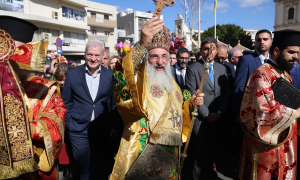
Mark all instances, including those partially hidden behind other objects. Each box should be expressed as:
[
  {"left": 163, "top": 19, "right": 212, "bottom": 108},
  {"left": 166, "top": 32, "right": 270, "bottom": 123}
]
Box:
[{"left": 62, "top": 39, "right": 118, "bottom": 180}]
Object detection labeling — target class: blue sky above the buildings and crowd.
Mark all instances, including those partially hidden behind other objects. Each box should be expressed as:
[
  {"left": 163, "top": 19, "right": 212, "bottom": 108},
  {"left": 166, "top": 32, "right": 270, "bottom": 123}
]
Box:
[{"left": 93, "top": 0, "right": 275, "bottom": 31}]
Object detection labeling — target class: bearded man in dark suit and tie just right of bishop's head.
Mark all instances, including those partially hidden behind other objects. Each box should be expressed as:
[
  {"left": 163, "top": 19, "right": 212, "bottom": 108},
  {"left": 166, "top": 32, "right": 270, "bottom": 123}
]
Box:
[{"left": 171, "top": 48, "right": 190, "bottom": 89}]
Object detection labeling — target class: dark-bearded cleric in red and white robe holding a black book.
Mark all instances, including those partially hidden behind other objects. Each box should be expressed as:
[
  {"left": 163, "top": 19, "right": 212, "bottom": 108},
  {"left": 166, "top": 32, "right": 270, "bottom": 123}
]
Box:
[{"left": 237, "top": 30, "right": 300, "bottom": 180}]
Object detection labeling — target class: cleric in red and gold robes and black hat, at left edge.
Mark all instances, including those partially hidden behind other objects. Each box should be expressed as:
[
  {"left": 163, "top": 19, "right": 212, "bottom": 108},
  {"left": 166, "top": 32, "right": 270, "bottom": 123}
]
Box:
[{"left": 0, "top": 16, "right": 66, "bottom": 180}]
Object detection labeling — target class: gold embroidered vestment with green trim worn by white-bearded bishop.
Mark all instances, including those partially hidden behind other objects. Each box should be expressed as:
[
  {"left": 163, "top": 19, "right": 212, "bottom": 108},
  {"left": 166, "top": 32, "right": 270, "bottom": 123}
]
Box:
[{"left": 111, "top": 46, "right": 191, "bottom": 180}]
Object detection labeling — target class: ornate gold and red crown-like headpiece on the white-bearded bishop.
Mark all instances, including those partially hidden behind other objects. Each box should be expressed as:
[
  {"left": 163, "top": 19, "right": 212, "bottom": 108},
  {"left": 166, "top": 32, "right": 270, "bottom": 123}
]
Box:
[{"left": 149, "top": 27, "right": 172, "bottom": 52}]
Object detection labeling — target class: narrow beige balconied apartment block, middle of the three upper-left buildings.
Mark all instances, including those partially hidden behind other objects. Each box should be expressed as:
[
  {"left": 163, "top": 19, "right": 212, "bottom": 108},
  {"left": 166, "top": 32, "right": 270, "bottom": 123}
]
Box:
[{"left": 86, "top": 1, "right": 117, "bottom": 55}]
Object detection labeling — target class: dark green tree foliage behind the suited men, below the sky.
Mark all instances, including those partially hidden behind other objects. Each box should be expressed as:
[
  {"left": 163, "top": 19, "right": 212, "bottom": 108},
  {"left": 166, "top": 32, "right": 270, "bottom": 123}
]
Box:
[{"left": 193, "top": 24, "right": 253, "bottom": 49}]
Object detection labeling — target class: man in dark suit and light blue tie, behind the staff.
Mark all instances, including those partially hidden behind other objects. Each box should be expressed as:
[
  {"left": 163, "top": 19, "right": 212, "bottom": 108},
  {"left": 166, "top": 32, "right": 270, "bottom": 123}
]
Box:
[{"left": 182, "top": 37, "right": 230, "bottom": 180}]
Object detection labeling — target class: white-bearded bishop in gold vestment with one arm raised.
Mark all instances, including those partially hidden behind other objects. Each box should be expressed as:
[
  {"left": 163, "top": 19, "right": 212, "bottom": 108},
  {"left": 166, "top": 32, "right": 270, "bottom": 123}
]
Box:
[{"left": 110, "top": 18, "right": 203, "bottom": 180}]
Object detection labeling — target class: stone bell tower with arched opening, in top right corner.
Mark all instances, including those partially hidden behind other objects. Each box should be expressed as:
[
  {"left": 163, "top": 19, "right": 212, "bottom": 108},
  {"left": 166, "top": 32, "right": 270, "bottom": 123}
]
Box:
[{"left": 274, "top": 0, "right": 300, "bottom": 31}]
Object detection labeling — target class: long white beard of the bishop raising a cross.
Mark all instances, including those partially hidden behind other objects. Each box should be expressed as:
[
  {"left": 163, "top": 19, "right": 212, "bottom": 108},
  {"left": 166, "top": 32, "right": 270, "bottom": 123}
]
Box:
[{"left": 146, "top": 60, "right": 174, "bottom": 93}]
